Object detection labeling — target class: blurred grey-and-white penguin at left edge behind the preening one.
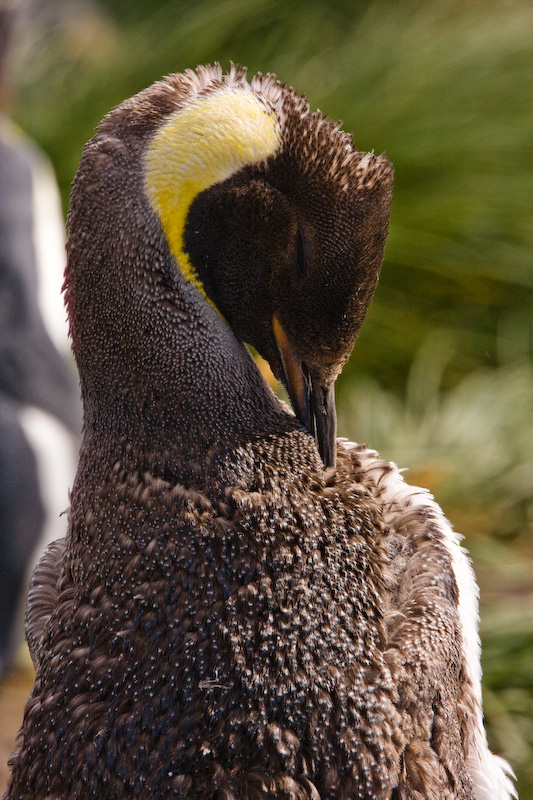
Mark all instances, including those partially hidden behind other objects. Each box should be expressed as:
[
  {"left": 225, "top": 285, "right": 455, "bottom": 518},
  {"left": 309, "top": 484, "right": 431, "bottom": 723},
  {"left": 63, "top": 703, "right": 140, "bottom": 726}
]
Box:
[{"left": 0, "top": 0, "right": 81, "bottom": 677}]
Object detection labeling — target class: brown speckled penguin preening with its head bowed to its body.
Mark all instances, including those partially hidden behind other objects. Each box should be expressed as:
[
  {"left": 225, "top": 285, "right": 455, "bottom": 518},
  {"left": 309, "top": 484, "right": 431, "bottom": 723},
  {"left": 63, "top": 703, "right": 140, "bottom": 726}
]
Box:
[{"left": 6, "top": 66, "right": 513, "bottom": 800}]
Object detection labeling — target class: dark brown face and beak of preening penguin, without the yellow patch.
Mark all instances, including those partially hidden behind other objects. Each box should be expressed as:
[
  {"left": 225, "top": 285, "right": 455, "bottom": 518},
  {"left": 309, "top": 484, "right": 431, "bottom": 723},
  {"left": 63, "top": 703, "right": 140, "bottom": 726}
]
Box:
[{"left": 177, "top": 77, "right": 392, "bottom": 466}]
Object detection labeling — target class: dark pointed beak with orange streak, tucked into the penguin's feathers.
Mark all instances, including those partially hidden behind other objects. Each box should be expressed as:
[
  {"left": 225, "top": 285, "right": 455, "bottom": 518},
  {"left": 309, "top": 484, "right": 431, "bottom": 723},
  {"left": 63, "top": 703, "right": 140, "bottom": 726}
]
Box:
[{"left": 272, "top": 315, "right": 337, "bottom": 469}]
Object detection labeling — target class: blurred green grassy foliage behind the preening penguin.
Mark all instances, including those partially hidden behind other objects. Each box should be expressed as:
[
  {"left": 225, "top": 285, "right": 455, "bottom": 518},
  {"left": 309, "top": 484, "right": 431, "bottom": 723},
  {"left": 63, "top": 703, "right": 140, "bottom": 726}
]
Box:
[{"left": 8, "top": 0, "right": 533, "bottom": 800}]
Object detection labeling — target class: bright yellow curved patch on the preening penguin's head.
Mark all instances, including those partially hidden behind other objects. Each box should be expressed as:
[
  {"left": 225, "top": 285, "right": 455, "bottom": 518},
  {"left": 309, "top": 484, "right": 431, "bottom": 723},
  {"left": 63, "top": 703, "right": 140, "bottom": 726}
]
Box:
[{"left": 145, "top": 88, "right": 280, "bottom": 297}]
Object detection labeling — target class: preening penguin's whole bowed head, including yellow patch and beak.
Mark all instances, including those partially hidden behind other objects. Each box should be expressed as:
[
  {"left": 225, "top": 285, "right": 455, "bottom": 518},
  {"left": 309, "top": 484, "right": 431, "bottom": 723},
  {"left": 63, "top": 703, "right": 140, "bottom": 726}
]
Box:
[{"left": 73, "top": 65, "right": 392, "bottom": 466}]
